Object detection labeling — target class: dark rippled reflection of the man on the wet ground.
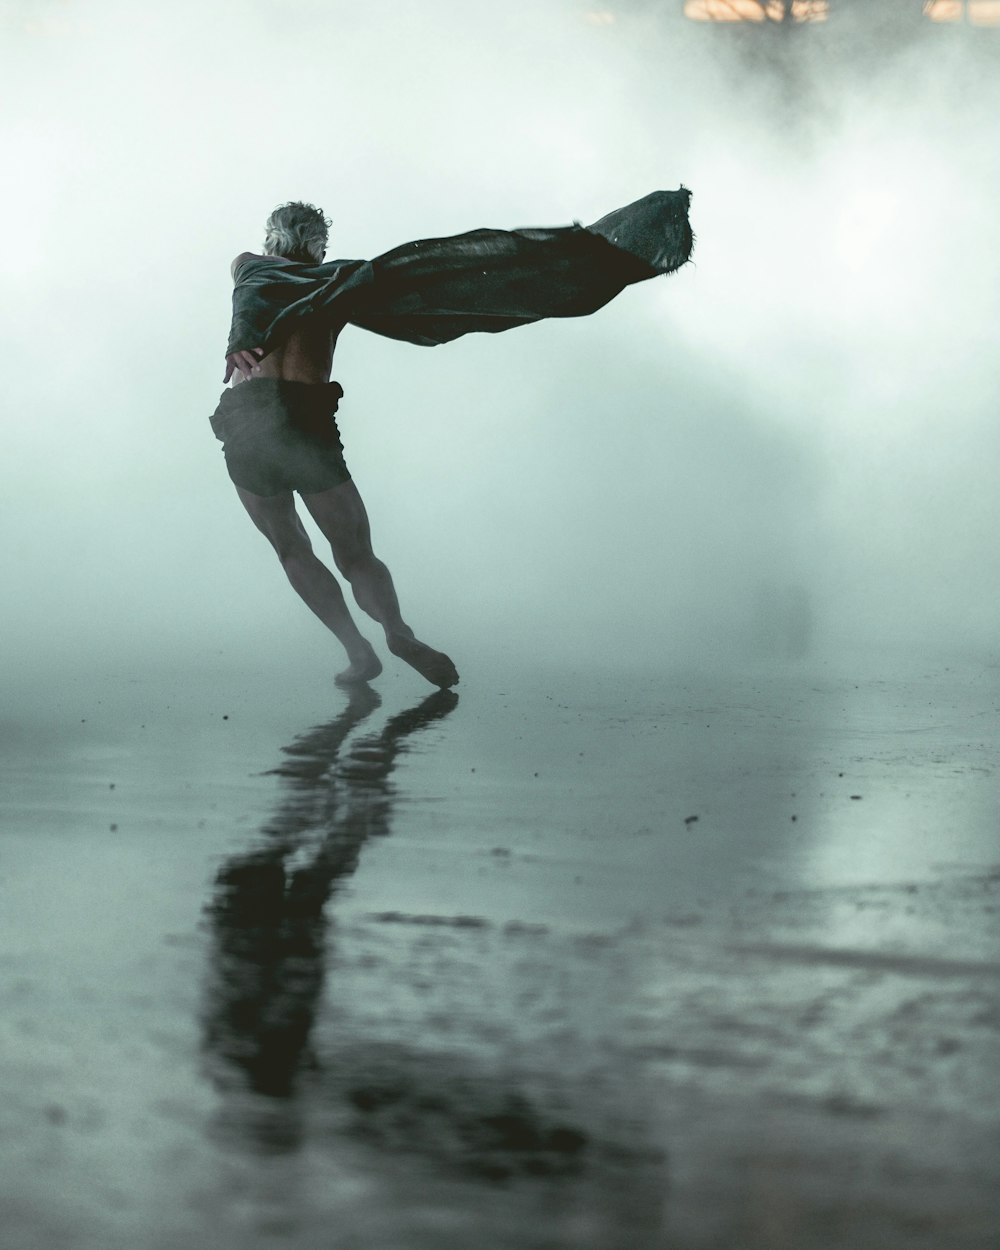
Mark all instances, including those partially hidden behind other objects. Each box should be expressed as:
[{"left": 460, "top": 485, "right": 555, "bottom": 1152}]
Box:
[{"left": 205, "top": 685, "right": 459, "bottom": 1096}]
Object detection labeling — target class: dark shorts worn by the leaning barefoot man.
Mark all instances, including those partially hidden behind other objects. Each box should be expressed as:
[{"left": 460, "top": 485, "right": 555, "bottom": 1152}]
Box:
[{"left": 211, "top": 378, "right": 351, "bottom": 495}]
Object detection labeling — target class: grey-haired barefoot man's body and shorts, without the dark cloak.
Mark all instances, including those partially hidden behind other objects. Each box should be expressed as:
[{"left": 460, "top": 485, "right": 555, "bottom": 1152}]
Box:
[{"left": 216, "top": 204, "right": 459, "bottom": 688}]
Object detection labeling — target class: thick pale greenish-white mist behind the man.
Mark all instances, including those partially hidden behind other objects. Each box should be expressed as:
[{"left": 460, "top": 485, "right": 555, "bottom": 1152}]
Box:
[{"left": 0, "top": 0, "right": 1000, "bottom": 670}]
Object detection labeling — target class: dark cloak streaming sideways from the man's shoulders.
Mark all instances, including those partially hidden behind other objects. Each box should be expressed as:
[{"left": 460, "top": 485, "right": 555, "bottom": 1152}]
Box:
[{"left": 226, "top": 188, "right": 694, "bottom": 355}]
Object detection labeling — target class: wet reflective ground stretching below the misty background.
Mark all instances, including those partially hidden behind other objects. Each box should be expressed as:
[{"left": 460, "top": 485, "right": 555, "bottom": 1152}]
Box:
[{"left": 0, "top": 663, "right": 1000, "bottom": 1250}]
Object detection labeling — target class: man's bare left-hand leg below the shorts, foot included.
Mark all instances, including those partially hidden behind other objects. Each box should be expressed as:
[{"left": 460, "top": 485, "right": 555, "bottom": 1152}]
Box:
[{"left": 236, "top": 486, "right": 383, "bottom": 685}]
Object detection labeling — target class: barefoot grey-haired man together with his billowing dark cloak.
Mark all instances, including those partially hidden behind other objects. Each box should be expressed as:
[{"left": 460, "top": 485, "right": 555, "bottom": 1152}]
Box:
[{"left": 211, "top": 188, "right": 694, "bottom": 689}]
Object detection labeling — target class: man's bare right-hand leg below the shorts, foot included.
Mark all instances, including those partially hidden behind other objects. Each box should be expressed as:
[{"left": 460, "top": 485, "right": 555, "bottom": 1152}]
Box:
[{"left": 303, "top": 481, "right": 459, "bottom": 688}]
